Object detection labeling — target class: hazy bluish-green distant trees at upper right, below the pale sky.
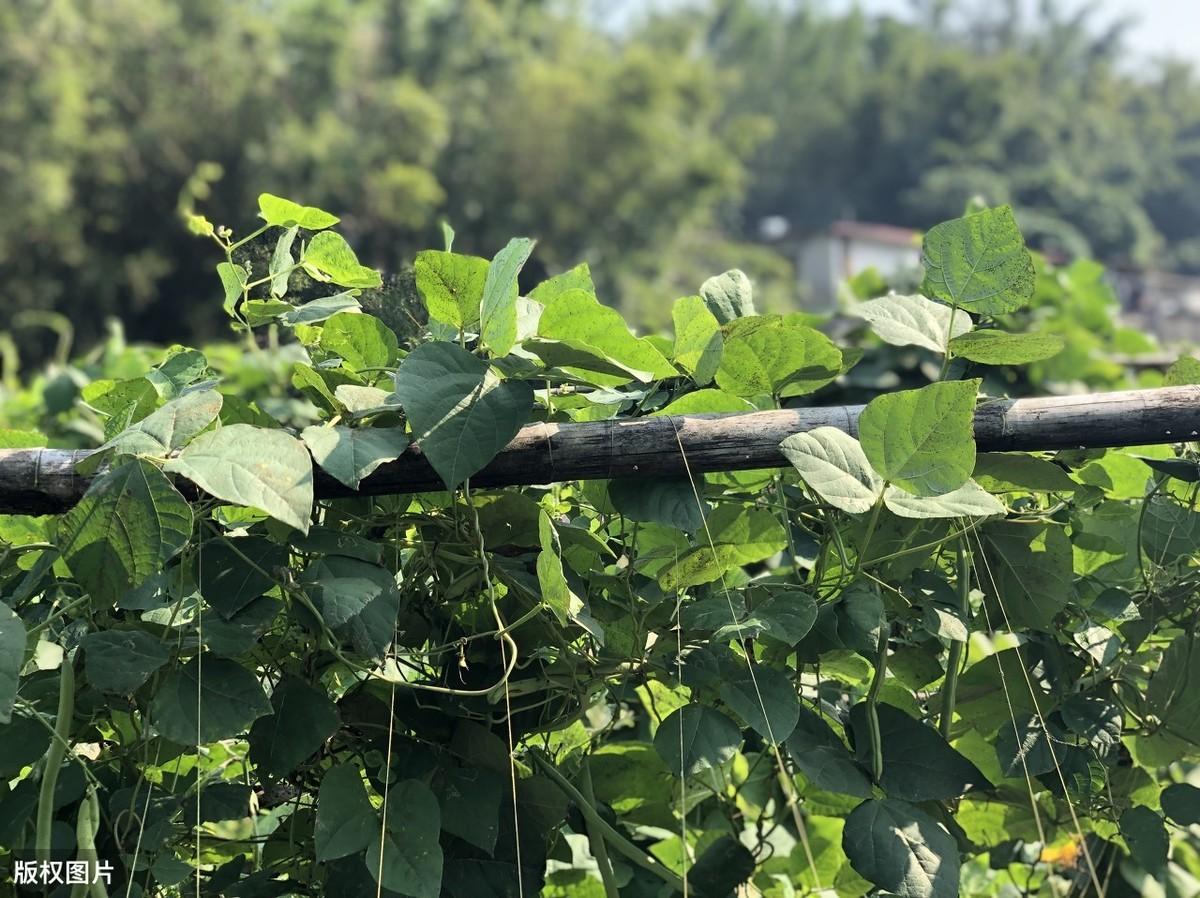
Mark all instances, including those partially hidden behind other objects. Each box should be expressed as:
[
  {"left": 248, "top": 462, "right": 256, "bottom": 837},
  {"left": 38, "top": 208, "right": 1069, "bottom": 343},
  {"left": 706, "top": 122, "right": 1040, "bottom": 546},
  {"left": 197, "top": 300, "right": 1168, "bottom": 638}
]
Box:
[{"left": 688, "top": 0, "right": 1200, "bottom": 270}]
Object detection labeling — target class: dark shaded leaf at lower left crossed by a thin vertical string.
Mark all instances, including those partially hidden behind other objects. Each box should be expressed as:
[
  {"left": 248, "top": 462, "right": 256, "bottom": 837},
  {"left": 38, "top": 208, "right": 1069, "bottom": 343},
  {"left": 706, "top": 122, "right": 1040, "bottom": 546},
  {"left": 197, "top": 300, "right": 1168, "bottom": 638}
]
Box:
[{"left": 150, "top": 654, "right": 271, "bottom": 746}]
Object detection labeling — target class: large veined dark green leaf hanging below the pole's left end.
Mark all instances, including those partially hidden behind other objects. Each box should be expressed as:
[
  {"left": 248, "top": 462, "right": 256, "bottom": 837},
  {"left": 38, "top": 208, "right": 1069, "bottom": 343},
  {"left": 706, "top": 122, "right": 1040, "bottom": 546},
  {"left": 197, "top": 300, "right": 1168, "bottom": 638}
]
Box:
[{"left": 58, "top": 459, "right": 192, "bottom": 606}]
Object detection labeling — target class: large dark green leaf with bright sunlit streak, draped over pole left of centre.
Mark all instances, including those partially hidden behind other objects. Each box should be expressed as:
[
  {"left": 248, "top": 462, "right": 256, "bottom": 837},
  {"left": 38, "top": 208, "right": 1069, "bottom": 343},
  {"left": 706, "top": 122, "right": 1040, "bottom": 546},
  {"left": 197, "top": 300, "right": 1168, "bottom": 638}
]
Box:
[{"left": 396, "top": 343, "right": 533, "bottom": 490}]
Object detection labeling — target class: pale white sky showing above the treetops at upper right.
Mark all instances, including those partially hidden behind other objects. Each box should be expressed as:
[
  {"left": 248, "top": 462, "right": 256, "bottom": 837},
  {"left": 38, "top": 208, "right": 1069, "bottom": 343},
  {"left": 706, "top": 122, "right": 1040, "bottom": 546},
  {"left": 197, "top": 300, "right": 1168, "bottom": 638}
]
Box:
[{"left": 829, "top": 0, "right": 1200, "bottom": 68}]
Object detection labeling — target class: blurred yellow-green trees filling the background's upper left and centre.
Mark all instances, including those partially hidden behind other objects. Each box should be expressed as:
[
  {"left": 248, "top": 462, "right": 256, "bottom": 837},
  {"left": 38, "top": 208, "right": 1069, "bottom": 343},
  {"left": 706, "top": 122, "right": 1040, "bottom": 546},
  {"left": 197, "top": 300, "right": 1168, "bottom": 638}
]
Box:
[{"left": 0, "top": 0, "right": 754, "bottom": 355}]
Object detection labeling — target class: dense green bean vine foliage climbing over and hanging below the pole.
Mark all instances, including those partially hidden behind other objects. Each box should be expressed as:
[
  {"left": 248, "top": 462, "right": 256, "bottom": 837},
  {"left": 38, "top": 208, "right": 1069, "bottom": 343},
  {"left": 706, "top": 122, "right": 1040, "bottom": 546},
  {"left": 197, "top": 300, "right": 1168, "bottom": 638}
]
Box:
[{"left": 0, "top": 194, "right": 1200, "bottom": 898}]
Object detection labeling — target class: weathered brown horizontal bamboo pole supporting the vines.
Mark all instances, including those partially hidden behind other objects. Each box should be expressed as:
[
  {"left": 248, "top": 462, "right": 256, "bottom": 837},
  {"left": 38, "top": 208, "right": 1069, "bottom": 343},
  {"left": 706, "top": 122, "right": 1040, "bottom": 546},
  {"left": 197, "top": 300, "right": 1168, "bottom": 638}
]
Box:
[{"left": 0, "top": 387, "right": 1200, "bottom": 514}]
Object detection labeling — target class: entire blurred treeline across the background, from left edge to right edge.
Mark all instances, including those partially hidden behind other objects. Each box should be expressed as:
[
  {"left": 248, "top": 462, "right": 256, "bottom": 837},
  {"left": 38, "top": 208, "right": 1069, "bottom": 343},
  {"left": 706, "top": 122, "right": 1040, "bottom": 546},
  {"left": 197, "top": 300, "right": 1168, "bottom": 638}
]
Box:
[{"left": 0, "top": 0, "right": 1200, "bottom": 355}]
